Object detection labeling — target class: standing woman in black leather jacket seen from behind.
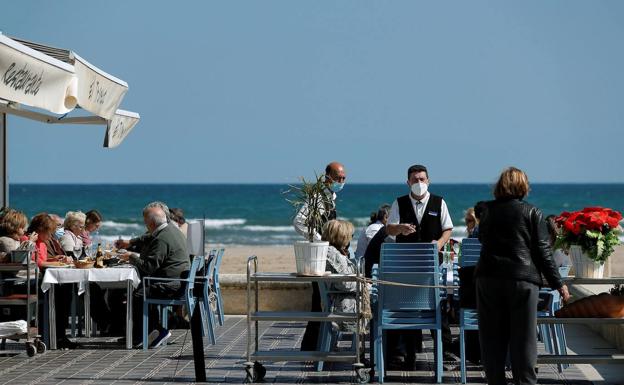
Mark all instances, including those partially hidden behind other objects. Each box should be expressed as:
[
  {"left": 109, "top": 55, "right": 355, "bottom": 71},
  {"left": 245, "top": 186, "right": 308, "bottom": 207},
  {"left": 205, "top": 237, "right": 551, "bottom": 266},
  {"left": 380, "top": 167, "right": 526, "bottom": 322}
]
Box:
[{"left": 475, "top": 167, "right": 569, "bottom": 385}]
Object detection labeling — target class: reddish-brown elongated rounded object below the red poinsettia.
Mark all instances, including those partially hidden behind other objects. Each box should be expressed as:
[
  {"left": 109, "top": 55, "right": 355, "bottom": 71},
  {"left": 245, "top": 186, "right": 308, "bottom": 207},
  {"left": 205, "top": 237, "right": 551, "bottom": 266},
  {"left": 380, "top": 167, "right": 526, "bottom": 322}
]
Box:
[{"left": 555, "top": 293, "right": 624, "bottom": 318}]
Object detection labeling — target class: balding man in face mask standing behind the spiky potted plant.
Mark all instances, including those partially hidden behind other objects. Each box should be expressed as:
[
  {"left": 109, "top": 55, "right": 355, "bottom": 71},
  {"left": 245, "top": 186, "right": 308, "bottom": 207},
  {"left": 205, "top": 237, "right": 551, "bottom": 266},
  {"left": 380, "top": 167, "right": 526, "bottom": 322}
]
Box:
[{"left": 293, "top": 162, "right": 347, "bottom": 351}]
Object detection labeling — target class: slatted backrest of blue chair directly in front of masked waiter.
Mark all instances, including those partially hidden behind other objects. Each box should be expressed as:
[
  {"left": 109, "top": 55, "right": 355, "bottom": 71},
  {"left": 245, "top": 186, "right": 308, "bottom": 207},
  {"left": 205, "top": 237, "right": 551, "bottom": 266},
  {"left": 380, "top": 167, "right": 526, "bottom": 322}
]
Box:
[{"left": 379, "top": 243, "right": 440, "bottom": 311}]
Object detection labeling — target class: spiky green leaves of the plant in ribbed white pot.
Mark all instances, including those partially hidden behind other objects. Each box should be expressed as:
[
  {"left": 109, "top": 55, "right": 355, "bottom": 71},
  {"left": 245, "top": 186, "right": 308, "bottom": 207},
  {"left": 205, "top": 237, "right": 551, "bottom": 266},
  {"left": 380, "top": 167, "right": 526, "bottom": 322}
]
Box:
[{"left": 283, "top": 174, "right": 334, "bottom": 242}]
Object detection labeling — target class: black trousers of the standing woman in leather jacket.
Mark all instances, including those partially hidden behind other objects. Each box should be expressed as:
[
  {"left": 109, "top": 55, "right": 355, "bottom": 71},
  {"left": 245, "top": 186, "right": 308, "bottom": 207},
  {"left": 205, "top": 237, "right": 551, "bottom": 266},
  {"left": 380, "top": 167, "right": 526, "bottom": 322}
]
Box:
[{"left": 476, "top": 277, "right": 539, "bottom": 385}]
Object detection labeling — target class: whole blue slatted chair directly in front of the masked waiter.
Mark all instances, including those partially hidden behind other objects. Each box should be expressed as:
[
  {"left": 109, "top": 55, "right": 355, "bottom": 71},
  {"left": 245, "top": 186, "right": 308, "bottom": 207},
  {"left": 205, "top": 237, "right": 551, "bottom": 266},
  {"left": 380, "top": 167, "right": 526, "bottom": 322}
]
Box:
[{"left": 374, "top": 243, "right": 442, "bottom": 383}]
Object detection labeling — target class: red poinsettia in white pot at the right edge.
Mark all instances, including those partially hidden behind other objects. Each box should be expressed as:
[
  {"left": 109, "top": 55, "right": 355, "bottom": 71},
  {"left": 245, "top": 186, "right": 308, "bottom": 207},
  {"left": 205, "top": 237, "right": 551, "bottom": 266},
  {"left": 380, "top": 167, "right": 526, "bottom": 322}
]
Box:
[{"left": 554, "top": 207, "right": 622, "bottom": 278}]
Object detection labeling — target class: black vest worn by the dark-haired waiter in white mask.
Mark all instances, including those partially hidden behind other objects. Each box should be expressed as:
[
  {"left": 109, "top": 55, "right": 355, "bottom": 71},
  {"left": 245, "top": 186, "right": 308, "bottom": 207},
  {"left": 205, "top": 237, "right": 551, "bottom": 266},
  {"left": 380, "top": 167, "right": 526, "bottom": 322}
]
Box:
[{"left": 396, "top": 194, "right": 442, "bottom": 243}]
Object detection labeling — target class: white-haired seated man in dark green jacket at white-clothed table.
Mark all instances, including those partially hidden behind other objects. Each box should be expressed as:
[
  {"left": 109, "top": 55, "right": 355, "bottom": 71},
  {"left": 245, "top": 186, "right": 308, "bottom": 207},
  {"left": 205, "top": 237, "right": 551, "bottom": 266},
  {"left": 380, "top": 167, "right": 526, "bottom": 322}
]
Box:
[{"left": 120, "top": 202, "right": 190, "bottom": 347}]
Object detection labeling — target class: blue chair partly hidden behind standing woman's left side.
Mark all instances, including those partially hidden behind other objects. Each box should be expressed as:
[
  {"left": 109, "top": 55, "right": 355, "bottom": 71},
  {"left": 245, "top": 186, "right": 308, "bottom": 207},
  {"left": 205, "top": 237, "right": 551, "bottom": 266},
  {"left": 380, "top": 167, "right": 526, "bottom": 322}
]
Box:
[{"left": 456, "top": 238, "right": 481, "bottom": 384}]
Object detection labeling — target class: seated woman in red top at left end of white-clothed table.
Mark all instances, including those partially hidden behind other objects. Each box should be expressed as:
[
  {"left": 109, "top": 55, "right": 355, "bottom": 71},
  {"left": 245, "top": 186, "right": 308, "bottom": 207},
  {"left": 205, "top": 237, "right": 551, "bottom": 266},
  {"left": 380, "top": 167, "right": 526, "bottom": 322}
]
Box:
[{"left": 28, "top": 213, "right": 77, "bottom": 349}]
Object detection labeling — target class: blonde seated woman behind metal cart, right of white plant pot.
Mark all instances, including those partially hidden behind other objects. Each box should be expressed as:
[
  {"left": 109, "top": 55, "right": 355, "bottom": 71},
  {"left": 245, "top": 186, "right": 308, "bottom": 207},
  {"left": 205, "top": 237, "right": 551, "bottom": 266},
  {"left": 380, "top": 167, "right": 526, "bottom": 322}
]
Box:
[{"left": 322, "top": 220, "right": 370, "bottom": 331}]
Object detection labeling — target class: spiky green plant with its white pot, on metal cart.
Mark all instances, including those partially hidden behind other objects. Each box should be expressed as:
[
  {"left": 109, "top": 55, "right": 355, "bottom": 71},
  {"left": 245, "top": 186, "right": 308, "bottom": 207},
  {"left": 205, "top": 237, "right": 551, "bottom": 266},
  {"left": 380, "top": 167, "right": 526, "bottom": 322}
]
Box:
[{"left": 284, "top": 175, "right": 334, "bottom": 275}]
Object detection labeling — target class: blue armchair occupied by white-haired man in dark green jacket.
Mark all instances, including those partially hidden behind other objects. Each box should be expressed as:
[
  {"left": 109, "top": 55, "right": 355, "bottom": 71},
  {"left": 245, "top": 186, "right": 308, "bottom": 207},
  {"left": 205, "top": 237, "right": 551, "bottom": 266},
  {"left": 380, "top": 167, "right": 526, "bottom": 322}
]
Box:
[{"left": 143, "top": 256, "right": 204, "bottom": 350}]
